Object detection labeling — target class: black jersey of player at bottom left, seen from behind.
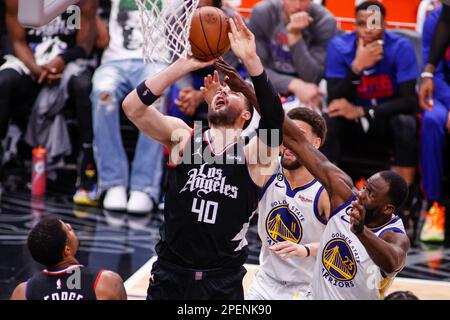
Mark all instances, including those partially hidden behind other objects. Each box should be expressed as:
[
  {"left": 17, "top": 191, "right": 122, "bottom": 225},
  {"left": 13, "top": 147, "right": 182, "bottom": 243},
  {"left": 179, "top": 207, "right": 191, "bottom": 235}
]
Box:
[{"left": 25, "top": 265, "right": 102, "bottom": 300}]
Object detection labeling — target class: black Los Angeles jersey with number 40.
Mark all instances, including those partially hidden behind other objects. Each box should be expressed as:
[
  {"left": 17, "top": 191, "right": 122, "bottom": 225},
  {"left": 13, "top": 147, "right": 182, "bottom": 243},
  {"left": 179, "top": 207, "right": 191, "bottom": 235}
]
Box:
[{"left": 156, "top": 128, "right": 259, "bottom": 269}]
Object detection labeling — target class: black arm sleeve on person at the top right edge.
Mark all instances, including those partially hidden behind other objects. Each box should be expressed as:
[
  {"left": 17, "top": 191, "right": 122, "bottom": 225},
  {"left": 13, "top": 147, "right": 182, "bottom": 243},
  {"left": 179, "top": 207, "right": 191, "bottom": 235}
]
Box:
[{"left": 427, "top": 4, "right": 450, "bottom": 67}]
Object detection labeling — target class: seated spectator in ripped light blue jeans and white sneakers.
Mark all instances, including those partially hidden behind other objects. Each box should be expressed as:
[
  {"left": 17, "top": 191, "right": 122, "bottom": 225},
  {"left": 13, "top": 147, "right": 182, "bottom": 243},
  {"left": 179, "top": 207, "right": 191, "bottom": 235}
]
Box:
[{"left": 91, "top": 0, "right": 170, "bottom": 212}]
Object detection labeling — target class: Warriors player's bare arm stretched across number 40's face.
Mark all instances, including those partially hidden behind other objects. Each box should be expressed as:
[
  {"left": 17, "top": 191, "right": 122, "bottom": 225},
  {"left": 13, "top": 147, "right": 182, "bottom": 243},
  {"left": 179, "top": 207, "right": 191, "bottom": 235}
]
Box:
[{"left": 215, "top": 60, "right": 353, "bottom": 211}]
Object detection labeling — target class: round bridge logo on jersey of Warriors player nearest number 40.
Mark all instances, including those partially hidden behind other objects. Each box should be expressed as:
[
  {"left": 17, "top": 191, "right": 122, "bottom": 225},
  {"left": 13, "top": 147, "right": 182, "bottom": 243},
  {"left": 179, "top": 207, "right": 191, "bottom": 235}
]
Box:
[{"left": 266, "top": 205, "right": 303, "bottom": 243}]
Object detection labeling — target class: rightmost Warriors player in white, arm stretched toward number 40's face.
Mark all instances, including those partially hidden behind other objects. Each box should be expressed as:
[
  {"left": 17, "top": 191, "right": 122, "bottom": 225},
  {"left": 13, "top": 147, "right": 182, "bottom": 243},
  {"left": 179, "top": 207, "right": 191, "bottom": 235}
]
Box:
[{"left": 219, "top": 54, "right": 410, "bottom": 300}]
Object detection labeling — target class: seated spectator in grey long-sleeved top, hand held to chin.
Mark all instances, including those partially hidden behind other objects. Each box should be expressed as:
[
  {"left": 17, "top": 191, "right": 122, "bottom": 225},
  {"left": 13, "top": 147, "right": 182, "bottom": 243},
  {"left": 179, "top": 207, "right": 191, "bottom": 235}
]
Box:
[{"left": 249, "top": 0, "right": 336, "bottom": 107}]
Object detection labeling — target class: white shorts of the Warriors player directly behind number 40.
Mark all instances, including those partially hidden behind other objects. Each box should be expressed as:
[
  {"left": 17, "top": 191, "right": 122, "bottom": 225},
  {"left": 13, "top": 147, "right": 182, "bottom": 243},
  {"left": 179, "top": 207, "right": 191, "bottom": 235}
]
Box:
[{"left": 245, "top": 269, "right": 310, "bottom": 300}]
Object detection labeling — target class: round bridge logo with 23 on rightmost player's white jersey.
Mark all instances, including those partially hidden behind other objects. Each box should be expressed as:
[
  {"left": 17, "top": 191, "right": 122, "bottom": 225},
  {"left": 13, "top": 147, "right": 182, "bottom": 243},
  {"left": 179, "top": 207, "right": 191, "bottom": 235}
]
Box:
[{"left": 322, "top": 232, "right": 360, "bottom": 288}]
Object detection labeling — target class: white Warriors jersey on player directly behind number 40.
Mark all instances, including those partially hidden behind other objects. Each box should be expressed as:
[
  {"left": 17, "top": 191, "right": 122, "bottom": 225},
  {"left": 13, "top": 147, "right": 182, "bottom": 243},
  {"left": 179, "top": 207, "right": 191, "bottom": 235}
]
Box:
[{"left": 258, "top": 165, "right": 326, "bottom": 286}]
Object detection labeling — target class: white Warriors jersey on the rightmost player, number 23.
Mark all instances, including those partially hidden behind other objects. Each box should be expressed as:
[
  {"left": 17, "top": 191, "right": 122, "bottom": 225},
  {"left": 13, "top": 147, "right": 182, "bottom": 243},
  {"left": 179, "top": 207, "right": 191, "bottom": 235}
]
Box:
[{"left": 311, "top": 197, "right": 405, "bottom": 300}]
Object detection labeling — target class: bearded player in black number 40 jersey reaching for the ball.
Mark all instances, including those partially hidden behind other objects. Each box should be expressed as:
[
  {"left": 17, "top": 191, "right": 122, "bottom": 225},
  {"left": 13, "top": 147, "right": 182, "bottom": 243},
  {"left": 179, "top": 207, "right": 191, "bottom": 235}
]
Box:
[{"left": 123, "top": 15, "right": 284, "bottom": 300}]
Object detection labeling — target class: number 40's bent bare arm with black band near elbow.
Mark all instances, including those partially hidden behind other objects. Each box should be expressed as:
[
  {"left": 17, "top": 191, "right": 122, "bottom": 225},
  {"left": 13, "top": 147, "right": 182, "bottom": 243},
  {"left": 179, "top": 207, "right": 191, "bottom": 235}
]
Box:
[{"left": 122, "top": 58, "right": 213, "bottom": 148}]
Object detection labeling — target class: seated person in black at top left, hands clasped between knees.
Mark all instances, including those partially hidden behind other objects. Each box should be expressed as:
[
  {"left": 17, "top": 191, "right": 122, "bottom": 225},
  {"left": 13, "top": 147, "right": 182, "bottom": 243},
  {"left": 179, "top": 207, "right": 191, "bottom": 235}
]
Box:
[{"left": 0, "top": 0, "right": 97, "bottom": 202}]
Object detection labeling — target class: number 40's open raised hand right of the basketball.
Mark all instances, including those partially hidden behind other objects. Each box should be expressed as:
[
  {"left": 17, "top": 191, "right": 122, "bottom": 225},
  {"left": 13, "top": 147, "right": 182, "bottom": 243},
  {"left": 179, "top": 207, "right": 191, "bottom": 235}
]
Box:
[{"left": 228, "top": 13, "right": 256, "bottom": 63}]
